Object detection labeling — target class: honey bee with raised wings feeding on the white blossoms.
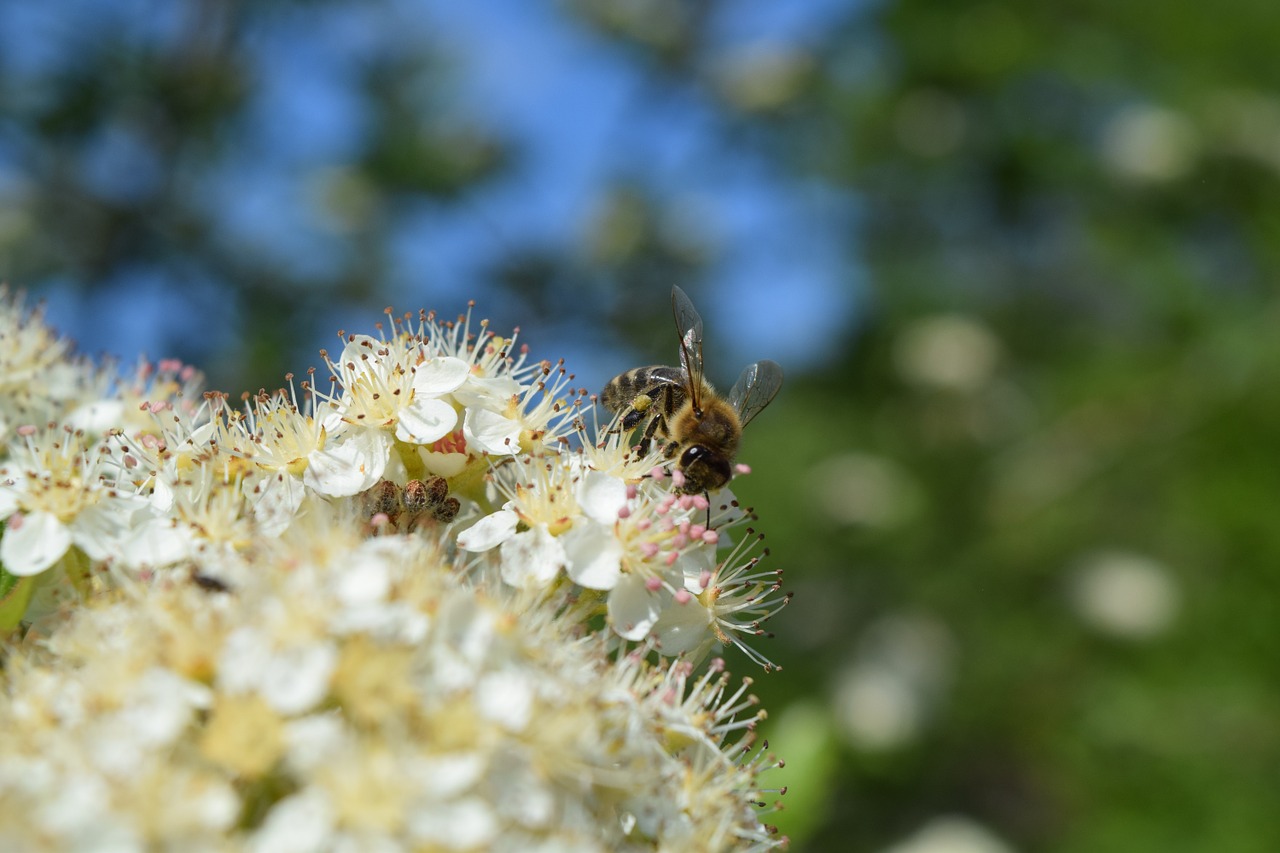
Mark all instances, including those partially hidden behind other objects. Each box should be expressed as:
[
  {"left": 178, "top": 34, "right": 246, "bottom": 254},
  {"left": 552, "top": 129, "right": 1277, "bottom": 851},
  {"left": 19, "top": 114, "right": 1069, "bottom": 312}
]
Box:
[{"left": 600, "top": 287, "right": 782, "bottom": 494}]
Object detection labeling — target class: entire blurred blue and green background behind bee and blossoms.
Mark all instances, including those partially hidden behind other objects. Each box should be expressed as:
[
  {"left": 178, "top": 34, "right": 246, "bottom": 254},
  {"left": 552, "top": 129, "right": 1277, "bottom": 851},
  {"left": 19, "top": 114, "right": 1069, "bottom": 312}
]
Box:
[{"left": 0, "top": 0, "right": 1280, "bottom": 853}]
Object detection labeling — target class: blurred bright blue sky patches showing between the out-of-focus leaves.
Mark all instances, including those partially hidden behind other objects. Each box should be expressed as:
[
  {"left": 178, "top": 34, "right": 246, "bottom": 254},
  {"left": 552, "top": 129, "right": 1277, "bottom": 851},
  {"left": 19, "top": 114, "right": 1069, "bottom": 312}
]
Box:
[{"left": 0, "top": 0, "right": 860, "bottom": 391}]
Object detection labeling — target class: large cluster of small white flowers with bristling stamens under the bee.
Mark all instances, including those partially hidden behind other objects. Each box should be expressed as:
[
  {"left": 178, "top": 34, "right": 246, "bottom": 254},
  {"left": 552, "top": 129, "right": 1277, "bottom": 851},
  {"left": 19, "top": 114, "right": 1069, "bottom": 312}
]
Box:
[{"left": 0, "top": 295, "right": 787, "bottom": 850}]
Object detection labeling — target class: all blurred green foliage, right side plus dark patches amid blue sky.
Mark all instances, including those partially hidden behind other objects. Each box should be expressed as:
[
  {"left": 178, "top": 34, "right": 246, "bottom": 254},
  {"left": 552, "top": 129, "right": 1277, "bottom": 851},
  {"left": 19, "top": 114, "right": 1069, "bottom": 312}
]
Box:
[{"left": 9, "top": 0, "right": 1280, "bottom": 853}]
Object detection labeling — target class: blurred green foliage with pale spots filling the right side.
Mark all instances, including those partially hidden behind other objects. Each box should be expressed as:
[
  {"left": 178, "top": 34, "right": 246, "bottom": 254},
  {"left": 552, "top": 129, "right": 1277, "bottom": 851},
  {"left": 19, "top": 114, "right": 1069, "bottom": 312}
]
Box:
[{"left": 742, "top": 0, "right": 1280, "bottom": 853}]
